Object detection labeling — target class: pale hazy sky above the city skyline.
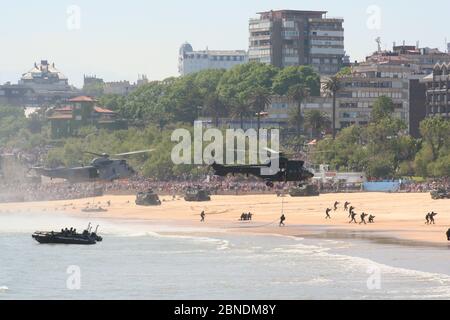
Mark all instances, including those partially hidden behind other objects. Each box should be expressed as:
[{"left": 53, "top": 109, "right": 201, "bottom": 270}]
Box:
[{"left": 0, "top": 0, "right": 450, "bottom": 86}]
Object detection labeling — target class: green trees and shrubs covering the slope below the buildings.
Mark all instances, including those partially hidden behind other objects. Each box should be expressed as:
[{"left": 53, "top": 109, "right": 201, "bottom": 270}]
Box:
[{"left": 0, "top": 63, "right": 450, "bottom": 179}]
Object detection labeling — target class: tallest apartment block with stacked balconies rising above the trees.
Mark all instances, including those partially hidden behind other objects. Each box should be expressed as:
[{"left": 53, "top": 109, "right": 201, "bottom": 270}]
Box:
[{"left": 249, "top": 10, "right": 345, "bottom": 74}]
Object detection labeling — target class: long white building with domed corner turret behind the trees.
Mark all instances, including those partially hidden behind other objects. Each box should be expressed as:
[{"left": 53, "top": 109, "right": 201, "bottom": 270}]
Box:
[{"left": 178, "top": 43, "right": 248, "bottom": 75}]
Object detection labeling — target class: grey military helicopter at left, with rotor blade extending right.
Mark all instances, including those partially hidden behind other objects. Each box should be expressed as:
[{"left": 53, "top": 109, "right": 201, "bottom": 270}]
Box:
[{"left": 32, "top": 149, "right": 154, "bottom": 182}]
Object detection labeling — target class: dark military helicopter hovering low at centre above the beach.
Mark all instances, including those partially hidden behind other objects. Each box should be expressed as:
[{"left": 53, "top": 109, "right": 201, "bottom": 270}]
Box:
[{"left": 211, "top": 148, "right": 314, "bottom": 188}]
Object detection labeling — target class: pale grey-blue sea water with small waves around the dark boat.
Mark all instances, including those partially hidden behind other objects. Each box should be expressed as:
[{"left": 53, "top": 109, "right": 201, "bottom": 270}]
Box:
[{"left": 0, "top": 213, "right": 450, "bottom": 300}]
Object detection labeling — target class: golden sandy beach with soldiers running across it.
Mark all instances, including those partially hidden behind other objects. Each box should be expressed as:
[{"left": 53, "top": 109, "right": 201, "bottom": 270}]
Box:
[{"left": 0, "top": 193, "right": 450, "bottom": 246}]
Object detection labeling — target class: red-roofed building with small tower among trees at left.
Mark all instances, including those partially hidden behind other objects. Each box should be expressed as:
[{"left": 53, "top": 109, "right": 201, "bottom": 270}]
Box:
[{"left": 47, "top": 96, "right": 127, "bottom": 139}]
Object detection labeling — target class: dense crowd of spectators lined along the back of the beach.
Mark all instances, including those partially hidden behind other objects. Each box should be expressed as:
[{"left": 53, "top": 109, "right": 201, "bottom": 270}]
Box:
[{"left": 0, "top": 177, "right": 450, "bottom": 202}]
